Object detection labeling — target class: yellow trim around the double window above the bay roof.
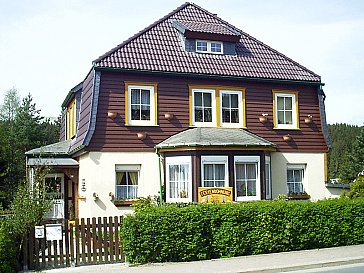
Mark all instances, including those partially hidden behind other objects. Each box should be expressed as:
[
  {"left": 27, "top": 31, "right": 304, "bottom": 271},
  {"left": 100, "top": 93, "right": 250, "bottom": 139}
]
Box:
[{"left": 188, "top": 84, "right": 246, "bottom": 128}]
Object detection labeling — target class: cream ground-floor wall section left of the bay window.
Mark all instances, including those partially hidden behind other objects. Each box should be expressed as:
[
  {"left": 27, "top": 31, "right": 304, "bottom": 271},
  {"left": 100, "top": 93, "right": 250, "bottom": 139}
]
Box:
[{"left": 78, "top": 152, "right": 160, "bottom": 217}]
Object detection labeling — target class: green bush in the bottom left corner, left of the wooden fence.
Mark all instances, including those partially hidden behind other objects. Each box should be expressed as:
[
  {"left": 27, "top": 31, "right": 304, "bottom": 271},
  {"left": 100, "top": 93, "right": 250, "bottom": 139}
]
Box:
[{"left": 0, "top": 220, "right": 18, "bottom": 273}]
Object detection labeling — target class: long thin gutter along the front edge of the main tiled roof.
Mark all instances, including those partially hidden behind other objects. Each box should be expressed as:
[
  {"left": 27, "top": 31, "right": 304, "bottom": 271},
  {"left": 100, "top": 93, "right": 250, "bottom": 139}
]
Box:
[{"left": 94, "top": 66, "right": 325, "bottom": 86}]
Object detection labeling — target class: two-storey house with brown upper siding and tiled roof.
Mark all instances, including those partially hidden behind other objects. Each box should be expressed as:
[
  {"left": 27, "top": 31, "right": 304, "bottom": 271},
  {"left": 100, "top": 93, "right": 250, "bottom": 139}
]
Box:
[{"left": 27, "top": 3, "right": 330, "bottom": 218}]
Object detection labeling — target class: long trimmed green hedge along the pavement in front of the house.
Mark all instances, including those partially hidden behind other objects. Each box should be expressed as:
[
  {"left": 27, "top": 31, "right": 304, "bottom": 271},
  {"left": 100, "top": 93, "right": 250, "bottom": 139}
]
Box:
[{"left": 121, "top": 199, "right": 364, "bottom": 263}]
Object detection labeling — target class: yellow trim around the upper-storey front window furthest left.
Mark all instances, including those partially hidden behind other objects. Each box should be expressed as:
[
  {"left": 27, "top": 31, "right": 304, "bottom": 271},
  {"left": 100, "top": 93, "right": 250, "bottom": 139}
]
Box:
[{"left": 124, "top": 81, "right": 159, "bottom": 126}]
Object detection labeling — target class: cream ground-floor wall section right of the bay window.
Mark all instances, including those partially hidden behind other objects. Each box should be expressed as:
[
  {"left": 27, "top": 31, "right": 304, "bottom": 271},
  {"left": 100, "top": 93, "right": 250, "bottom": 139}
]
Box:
[{"left": 271, "top": 152, "right": 332, "bottom": 201}]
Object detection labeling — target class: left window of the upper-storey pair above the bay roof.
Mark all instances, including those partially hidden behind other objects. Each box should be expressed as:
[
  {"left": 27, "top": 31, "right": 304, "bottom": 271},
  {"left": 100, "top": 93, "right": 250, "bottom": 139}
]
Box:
[{"left": 192, "top": 89, "right": 216, "bottom": 126}]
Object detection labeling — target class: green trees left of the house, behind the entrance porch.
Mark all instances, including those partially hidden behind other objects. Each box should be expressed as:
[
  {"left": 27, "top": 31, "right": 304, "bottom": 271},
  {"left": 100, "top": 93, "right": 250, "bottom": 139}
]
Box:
[{"left": 0, "top": 88, "right": 59, "bottom": 207}]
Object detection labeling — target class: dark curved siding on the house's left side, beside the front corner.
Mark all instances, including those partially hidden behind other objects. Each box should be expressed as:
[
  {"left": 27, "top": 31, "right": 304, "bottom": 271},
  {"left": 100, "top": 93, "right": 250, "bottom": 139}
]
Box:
[{"left": 71, "top": 70, "right": 94, "bottom": 149}]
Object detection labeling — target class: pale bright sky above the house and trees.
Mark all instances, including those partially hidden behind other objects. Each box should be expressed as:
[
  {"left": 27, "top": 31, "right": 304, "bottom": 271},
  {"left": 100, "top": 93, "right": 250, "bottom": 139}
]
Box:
[{"left": 0, "top": 0, "right": 364, "bottom": 126}]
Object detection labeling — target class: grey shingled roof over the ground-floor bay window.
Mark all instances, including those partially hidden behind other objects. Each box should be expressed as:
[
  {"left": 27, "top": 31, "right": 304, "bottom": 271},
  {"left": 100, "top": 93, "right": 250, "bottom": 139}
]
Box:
[{"left": 155, "top": 128, "right": 276, "bottom": 149}]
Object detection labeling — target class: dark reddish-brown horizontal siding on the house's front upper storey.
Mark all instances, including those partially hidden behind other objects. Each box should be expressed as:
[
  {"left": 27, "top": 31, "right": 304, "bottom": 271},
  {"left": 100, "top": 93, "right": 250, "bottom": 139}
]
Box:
[{"left": 88, "top": 72, "right": 327, "bottom": 152}]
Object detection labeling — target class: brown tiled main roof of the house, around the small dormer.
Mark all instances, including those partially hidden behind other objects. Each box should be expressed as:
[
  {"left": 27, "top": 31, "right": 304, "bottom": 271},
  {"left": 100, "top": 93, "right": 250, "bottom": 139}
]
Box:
[{"left": 94, "top": 3, "right": 321, "bottom": 83}]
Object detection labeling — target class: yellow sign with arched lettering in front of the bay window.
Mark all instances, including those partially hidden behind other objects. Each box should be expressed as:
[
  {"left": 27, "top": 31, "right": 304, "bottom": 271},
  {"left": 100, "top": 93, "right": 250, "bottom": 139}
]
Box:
[{"left": 198, "top": 187, "right": 233, "bottom": 204}]
